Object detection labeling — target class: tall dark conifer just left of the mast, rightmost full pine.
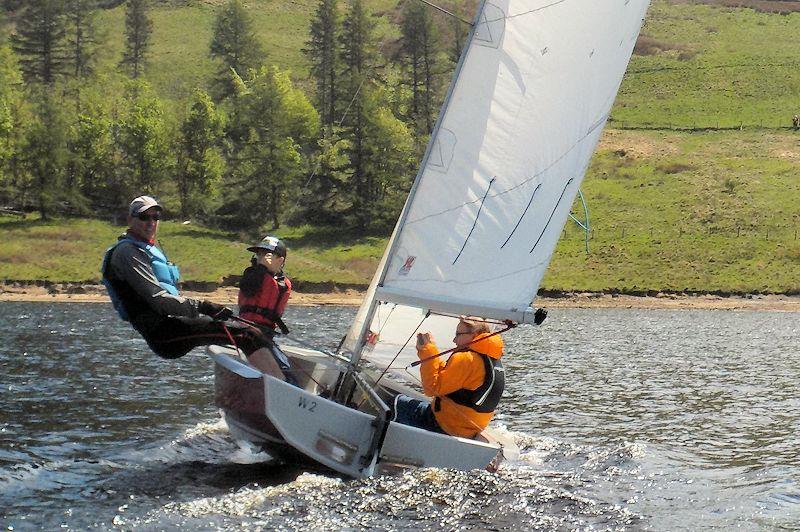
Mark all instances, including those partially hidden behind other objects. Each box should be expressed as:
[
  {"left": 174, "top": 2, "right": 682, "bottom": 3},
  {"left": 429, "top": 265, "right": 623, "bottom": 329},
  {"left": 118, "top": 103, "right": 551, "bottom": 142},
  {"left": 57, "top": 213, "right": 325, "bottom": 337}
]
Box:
[{"left": 400, "top": 1, "right": 440, "bottom": 135}]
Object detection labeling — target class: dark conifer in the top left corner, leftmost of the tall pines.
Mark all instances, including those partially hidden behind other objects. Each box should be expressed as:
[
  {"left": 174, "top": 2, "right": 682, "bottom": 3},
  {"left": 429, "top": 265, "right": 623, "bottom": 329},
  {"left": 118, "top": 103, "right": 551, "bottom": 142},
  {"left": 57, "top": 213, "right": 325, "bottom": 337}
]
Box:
[{"left": 12, "top": 0, "right": 67, "bottom": 85}]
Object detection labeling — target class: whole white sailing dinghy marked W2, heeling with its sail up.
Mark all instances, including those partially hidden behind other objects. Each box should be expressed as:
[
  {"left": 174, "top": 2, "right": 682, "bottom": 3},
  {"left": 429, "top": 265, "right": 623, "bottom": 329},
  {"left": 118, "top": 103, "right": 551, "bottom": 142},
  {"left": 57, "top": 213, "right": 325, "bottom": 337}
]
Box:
[{"left": 210, "top": 0, "right": 649, "bottom": 477}]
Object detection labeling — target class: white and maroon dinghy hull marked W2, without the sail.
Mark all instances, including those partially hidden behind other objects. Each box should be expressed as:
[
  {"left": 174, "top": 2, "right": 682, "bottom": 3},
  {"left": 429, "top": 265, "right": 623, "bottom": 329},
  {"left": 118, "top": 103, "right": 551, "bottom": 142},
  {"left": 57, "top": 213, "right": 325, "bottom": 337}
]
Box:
[{"left": 209, "top": 346, "right": 518, "bottom": 478}]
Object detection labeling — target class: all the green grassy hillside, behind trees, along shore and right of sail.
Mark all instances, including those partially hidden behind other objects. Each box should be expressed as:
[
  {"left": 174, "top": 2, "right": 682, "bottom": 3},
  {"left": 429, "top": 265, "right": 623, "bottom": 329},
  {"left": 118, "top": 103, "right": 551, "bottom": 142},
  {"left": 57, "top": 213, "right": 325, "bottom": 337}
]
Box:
[{"left": 0, "top": 0, "right": 800, "bottom": 292}]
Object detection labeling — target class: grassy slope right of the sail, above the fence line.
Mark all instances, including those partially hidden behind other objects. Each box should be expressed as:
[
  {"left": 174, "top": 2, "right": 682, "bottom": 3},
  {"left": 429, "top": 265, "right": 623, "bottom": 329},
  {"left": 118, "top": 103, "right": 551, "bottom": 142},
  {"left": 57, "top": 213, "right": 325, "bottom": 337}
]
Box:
[{"left": 612, "top": 0, "right": 800, "bottom": 127}]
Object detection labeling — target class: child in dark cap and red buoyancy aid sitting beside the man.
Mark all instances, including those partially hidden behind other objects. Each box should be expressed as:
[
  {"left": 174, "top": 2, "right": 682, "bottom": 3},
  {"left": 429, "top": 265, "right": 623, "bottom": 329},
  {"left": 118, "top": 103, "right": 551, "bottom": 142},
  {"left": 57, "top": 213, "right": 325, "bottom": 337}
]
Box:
[{"left": 238, "top": 236, "right": 297, "bottom": 384}]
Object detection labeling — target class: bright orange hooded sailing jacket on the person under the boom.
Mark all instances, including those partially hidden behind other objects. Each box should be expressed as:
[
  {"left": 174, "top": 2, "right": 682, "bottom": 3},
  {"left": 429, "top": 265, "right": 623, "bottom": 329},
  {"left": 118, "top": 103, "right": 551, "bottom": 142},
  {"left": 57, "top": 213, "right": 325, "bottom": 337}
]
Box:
[{"left": 417, "top": 333, "right": 503, "bottom": 438}]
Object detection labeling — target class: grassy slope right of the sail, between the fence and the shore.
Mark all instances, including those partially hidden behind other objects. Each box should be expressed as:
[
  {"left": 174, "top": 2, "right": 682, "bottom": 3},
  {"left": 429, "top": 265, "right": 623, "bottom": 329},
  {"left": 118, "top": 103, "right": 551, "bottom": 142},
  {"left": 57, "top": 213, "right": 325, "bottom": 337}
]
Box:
[{"left": 543, "top": 131, "right": 800, "bottom": 293}]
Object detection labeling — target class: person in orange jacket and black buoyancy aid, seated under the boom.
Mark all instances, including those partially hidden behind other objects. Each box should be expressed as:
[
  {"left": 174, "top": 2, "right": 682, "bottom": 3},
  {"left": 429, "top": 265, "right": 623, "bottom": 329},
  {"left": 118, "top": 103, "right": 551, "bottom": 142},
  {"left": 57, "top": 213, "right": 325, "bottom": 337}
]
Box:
[{"left": 393, "top": 317, "right": 505, "bottom": 438}]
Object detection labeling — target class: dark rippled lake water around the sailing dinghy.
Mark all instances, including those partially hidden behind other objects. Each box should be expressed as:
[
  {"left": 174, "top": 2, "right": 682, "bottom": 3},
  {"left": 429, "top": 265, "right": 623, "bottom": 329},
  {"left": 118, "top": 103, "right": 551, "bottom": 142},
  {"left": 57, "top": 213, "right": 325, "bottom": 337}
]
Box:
[{"left": 0, "top": 303, "right": 800, "bottom": 530}]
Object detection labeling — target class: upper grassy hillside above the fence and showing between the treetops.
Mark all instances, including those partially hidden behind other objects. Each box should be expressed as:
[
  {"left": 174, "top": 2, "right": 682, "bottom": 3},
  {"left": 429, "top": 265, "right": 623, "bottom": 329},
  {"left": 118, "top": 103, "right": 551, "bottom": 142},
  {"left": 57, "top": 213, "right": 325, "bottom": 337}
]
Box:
[{"left": 78, "top": 0, "right": 800, "bottom": 127}]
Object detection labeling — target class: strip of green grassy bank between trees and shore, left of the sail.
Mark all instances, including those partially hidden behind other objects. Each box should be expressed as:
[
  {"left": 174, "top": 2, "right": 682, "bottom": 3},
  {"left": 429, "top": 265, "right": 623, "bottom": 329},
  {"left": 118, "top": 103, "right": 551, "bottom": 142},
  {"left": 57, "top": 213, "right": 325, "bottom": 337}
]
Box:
[{"left": 0, "top": 216, "right": 386, "bottom": 285}]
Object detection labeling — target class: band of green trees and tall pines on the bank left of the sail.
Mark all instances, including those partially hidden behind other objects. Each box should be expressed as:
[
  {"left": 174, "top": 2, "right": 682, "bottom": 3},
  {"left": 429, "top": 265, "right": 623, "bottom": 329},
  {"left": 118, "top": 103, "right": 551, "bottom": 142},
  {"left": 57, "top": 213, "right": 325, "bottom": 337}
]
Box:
[{"left": 0, "top": 0, "right": 468, "bottom": 231}]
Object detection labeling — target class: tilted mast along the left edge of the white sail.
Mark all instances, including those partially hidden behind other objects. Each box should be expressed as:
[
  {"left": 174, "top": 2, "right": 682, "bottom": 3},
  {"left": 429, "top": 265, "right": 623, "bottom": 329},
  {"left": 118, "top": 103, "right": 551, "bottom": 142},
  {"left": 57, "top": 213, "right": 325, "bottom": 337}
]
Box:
[{"left": 350, "top": 0, "right": 487, "bottom": 365}]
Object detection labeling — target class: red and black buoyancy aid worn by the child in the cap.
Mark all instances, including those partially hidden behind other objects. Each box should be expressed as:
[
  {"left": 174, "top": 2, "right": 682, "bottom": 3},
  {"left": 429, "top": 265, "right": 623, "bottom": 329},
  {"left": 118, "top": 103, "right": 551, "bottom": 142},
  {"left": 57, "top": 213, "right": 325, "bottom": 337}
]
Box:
[{"left": 239, "top": 264, "right": 292, "bottom": 334}]
